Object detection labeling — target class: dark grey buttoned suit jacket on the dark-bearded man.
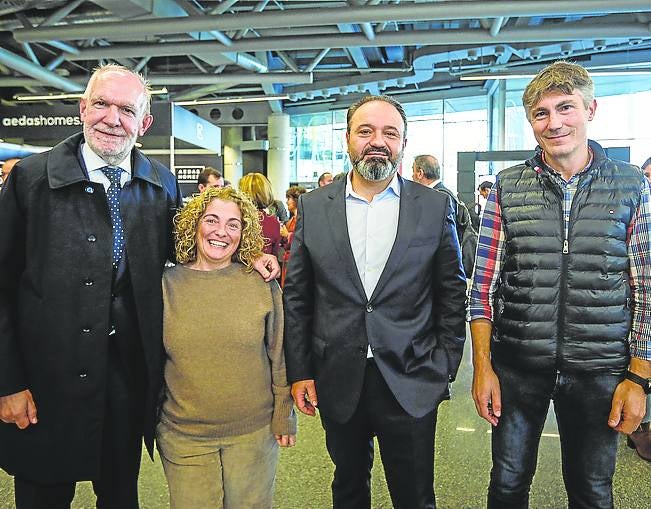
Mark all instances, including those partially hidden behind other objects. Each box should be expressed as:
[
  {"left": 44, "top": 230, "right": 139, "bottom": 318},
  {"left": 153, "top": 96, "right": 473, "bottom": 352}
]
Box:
[{"left": 283, "top": 178, "right": 466, "bottom": 422}]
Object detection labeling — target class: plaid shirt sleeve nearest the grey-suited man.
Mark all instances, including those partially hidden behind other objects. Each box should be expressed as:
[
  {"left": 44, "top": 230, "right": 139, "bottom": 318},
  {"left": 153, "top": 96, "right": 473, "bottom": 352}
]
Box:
[{"left": 466, "top": 181, "right": 505, "bottom": 321}]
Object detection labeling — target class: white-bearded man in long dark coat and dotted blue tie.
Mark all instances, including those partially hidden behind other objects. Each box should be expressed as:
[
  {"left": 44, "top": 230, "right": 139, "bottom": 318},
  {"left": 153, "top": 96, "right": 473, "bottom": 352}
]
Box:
[{"left": 0, "top": 64, "right": 278, "bottom": 509}]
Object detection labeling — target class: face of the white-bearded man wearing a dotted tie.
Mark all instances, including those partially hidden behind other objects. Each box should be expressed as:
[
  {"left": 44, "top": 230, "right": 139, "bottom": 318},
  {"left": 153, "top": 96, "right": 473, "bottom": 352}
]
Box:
[{"left": 79, "top": 71, "right": 153, "bottom": 165}]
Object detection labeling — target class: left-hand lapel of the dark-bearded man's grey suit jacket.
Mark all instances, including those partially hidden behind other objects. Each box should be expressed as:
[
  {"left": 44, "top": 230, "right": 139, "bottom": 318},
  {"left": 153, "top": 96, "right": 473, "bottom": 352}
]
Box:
[{"left": 325, "top": 179, "right": 366, "bottom": 301}]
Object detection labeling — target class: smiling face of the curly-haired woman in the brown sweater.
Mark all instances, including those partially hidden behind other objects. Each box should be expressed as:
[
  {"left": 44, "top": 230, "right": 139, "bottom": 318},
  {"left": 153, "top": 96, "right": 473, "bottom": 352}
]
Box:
[{"left": 194, "top": 199, "right": 242, "bottom": 270}]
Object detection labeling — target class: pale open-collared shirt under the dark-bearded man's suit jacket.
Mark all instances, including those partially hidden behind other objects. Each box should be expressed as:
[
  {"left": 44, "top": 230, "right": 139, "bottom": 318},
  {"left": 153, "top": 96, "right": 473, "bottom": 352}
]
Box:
[{"left": 346, "top": 172, "right": 400, "bottom": 357}]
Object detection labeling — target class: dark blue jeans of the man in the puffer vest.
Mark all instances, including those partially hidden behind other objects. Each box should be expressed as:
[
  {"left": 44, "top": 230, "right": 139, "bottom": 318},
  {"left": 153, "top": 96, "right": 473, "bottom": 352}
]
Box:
[{"left": 488, "top": 363, "right": 622, "bottom": 509}]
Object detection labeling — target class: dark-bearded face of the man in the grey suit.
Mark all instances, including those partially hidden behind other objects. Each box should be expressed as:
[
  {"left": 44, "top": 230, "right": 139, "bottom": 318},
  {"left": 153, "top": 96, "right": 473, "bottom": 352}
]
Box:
[{"left": 346, "top": 101, "right": 405, "bottom": 181}]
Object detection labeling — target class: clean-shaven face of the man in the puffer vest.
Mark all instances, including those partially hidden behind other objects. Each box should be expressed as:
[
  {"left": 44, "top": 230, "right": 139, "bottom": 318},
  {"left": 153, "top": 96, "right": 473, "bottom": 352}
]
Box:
[{"left": 529, "top": 89, "right": 597, "bottom": 169}]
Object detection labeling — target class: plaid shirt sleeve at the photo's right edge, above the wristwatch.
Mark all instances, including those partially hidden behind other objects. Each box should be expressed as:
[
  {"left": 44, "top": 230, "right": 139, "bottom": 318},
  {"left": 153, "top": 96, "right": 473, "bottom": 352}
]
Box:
[{"left": 628, "top": 181, "right": 651, "bottom": 361}]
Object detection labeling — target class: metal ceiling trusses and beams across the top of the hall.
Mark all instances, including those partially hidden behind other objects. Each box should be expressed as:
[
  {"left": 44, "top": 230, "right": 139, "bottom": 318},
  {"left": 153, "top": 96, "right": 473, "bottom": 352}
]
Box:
[{"left": 0, "top": 0, "right": 651, "bottom": 111}]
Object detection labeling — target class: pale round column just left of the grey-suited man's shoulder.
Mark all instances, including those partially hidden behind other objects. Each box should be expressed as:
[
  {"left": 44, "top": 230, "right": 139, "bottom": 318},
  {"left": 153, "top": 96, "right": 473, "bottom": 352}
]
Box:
[{"left": 267, "top": 113, "right": 292, "bottom": 200}]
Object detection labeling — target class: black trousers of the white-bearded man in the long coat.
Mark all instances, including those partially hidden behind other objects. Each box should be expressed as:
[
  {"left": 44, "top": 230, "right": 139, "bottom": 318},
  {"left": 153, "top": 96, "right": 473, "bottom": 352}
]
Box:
[{"left": 14, "top": 341, "right": 144, "bottom": 509}]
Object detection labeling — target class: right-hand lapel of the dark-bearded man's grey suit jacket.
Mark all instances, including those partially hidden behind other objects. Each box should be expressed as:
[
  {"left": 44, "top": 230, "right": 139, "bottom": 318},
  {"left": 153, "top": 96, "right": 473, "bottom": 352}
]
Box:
[{"left": 369, "top": 177, "right": 422, "bottom": 301}]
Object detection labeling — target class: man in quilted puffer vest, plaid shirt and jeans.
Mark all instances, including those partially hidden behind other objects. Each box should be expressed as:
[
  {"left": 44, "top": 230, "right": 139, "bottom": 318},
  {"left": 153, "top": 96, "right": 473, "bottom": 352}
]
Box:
[{"left": 469, "top": 62, "right": 651, "bottom": 509}]
